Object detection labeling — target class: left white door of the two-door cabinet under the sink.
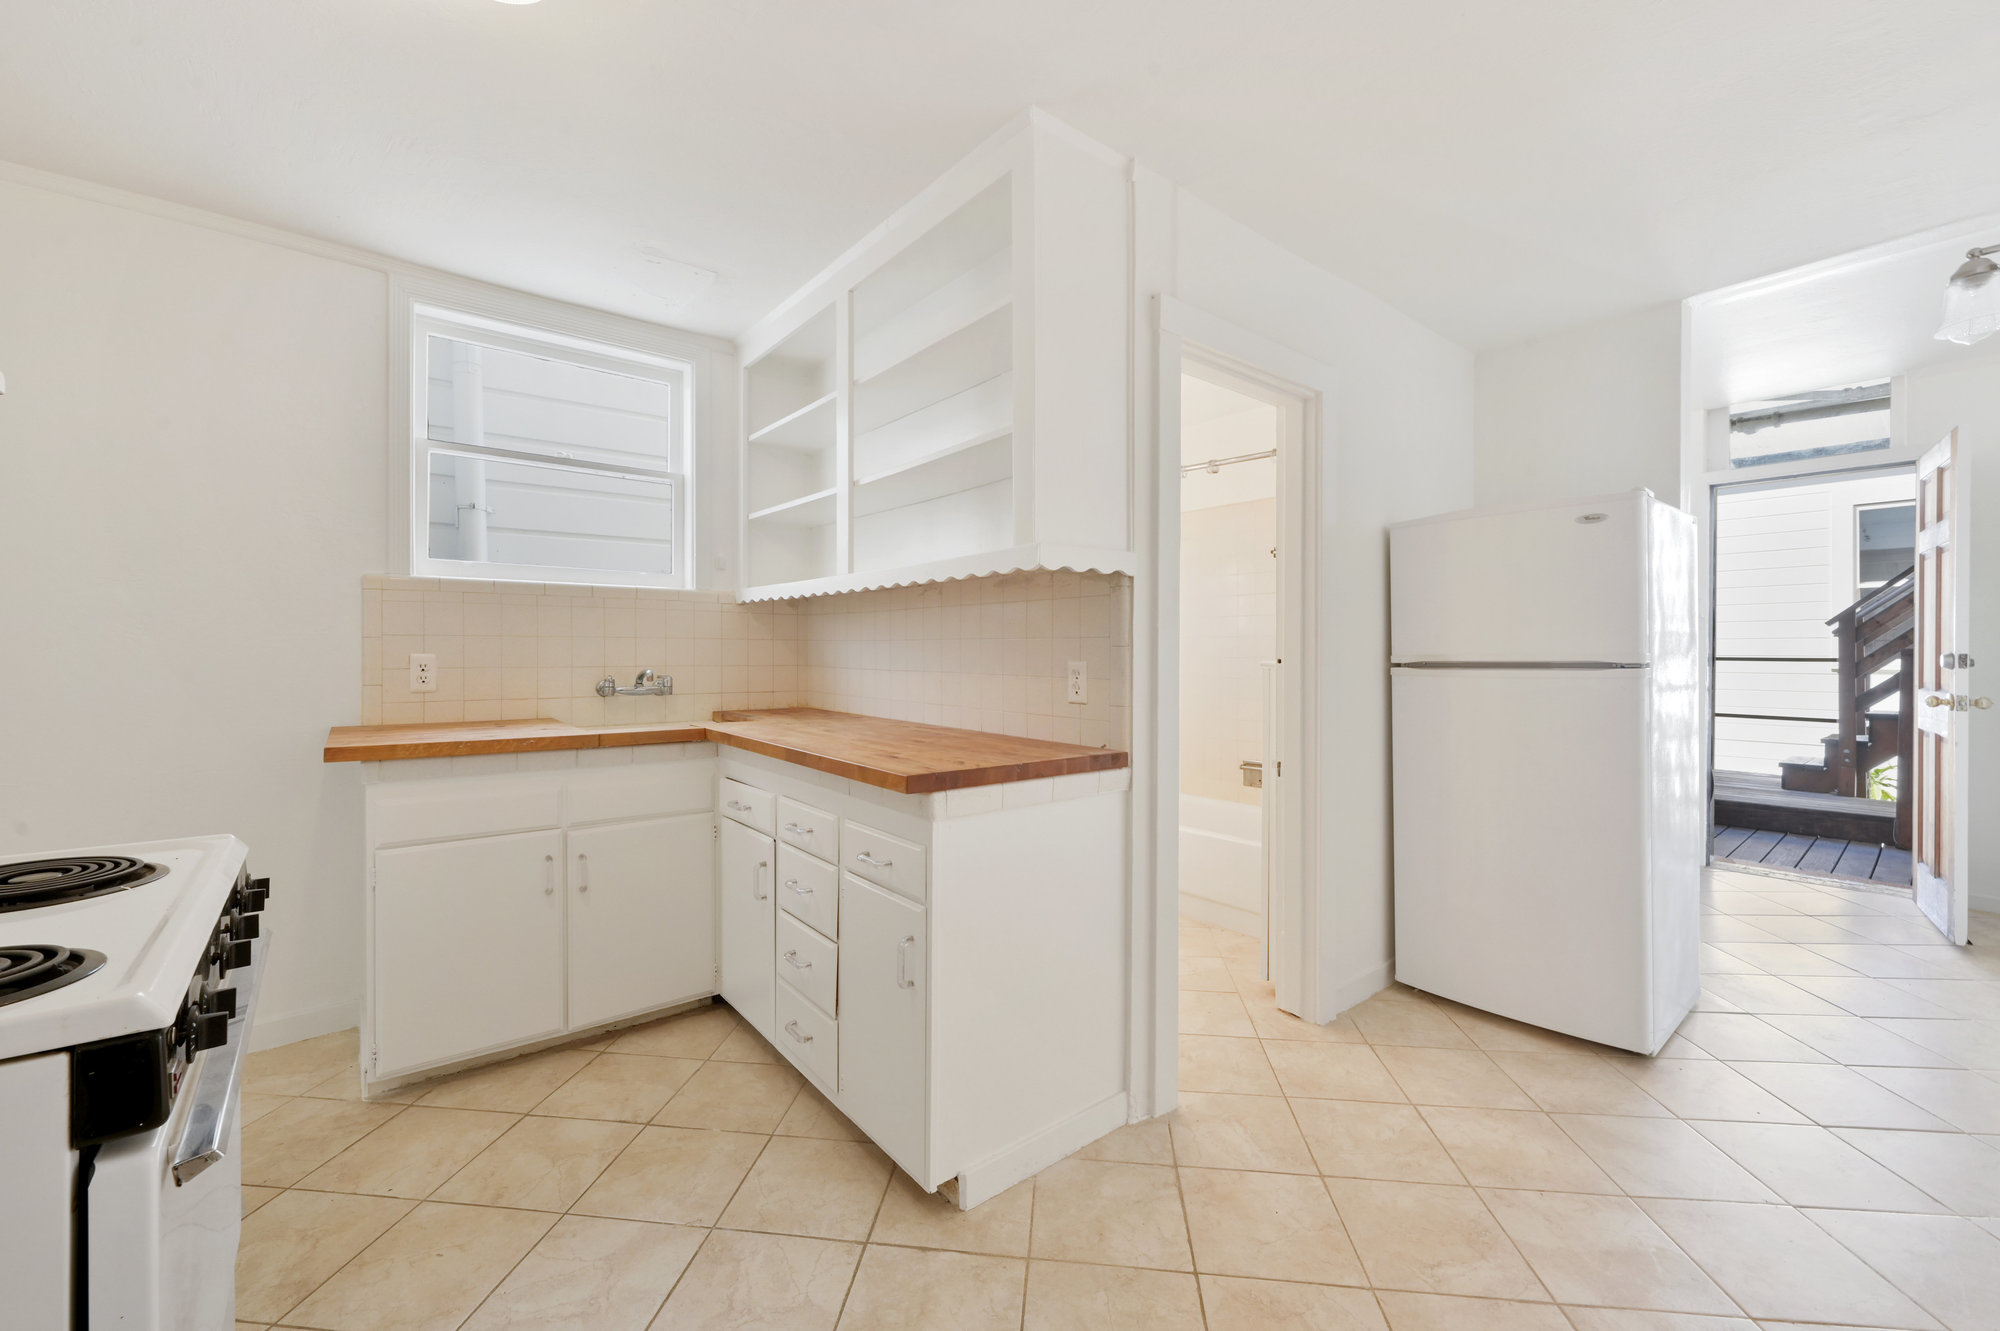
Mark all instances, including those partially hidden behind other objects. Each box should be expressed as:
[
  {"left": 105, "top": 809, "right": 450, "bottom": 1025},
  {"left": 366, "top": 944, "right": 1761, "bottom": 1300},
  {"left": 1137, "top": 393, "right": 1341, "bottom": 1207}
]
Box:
[{"left": 370, "top": 831, "right": 564, "bottom": 1077}]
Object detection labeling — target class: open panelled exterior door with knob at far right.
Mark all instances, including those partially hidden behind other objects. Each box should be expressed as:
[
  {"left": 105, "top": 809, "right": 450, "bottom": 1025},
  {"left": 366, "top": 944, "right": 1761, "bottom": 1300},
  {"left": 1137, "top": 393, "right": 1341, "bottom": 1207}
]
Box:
[{"left": 1910, "top": 430, "right": 1992, "bottom": 943}]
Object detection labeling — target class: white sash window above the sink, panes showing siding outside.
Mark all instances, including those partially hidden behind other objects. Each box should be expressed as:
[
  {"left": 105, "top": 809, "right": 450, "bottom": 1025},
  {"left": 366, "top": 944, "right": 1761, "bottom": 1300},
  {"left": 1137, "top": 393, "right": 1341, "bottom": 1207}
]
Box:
[{"left": 410, "top": 306, "right": 694, "bottom": 588}]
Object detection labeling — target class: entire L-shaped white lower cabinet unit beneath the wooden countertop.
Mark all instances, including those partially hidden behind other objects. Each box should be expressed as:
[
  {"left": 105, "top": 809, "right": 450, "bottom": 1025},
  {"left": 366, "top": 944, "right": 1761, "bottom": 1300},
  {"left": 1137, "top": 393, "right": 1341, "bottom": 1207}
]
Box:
[{"left": 362, "top": 747, "right": 1132, "bottom": 1205}]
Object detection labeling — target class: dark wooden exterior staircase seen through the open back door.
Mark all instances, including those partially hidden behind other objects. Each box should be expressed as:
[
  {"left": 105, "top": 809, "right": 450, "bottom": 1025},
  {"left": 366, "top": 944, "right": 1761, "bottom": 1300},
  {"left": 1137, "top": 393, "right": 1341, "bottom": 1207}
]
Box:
[{"left": 1778, "top": 570, "right": 1916, "bottom": 849}]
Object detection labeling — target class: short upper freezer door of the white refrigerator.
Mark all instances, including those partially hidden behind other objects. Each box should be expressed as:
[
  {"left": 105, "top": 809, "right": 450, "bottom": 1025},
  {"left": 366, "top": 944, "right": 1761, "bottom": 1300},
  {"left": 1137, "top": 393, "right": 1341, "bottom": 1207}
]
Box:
[{"left": 1388, "top": 490, "right": 1654, "bottom": 662}]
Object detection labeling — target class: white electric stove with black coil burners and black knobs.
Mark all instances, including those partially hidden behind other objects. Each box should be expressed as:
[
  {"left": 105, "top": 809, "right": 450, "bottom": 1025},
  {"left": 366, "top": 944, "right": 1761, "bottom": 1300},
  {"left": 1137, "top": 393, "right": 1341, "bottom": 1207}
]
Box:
[{"left": 0, "top": 835, "right": 270, "bottom": 1331}]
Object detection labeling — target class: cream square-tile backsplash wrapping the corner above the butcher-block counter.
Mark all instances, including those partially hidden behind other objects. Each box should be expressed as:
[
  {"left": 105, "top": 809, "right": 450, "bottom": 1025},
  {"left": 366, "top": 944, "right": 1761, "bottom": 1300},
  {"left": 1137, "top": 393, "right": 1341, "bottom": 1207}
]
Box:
[{"left": 360, "top": 572, "right": 1132, "bottom": 747}]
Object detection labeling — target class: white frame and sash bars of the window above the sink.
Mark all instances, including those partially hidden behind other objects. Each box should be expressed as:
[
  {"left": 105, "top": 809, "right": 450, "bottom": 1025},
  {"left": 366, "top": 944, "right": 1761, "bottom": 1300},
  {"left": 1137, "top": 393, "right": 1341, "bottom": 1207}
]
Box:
[{"left": 390, "top": 278, "right": 714, "bottom": 590}]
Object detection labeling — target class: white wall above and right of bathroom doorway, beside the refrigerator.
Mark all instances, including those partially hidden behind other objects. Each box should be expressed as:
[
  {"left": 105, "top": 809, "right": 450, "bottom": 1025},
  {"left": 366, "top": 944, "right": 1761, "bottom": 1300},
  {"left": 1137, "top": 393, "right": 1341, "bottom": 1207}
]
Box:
[{"left": 1138, "top": 188, "right": 1474, "bottom": 1015}]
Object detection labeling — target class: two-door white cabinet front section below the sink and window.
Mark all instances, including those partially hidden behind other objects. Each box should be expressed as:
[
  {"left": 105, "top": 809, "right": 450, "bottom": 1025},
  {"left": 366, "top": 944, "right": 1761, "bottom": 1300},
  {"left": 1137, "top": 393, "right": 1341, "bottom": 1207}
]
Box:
[{"left": 362, "top": 751, "right": 716, "bottom": 1087}]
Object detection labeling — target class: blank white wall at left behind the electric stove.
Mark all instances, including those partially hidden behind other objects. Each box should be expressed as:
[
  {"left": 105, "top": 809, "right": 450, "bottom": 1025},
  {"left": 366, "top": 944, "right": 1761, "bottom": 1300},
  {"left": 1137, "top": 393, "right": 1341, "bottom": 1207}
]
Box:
[{"left": 0, "top": 173, "right": 388, "bottom": 1029}]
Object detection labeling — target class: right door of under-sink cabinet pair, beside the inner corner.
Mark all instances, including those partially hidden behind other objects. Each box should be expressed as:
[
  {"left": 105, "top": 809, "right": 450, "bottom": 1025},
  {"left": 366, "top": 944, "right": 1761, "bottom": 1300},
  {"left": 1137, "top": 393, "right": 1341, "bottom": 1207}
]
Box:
[{"left": 568, "top": 813, "right": 716, "bottom": 1029}]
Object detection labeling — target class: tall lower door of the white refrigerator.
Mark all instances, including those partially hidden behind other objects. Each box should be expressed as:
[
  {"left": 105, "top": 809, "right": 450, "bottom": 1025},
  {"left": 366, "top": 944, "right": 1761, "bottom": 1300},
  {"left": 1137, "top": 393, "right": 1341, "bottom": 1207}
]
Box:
[{"left": 1392, "top": 669, "right": 1698, "bottom": 1053}]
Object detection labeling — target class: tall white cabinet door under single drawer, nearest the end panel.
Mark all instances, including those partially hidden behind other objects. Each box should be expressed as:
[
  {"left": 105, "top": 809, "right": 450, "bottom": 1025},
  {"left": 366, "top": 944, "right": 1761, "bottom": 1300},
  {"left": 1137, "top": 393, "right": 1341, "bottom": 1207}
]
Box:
[{"left": 840, "top": 873, "right": 930, "bottom": 1177}]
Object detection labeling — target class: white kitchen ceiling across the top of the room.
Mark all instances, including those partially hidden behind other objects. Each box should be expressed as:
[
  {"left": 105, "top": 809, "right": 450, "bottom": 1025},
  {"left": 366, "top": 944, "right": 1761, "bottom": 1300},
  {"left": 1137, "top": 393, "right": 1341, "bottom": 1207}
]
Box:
[{"left": 0, "top": 0, "right": 2000, "bottom": 346}]
